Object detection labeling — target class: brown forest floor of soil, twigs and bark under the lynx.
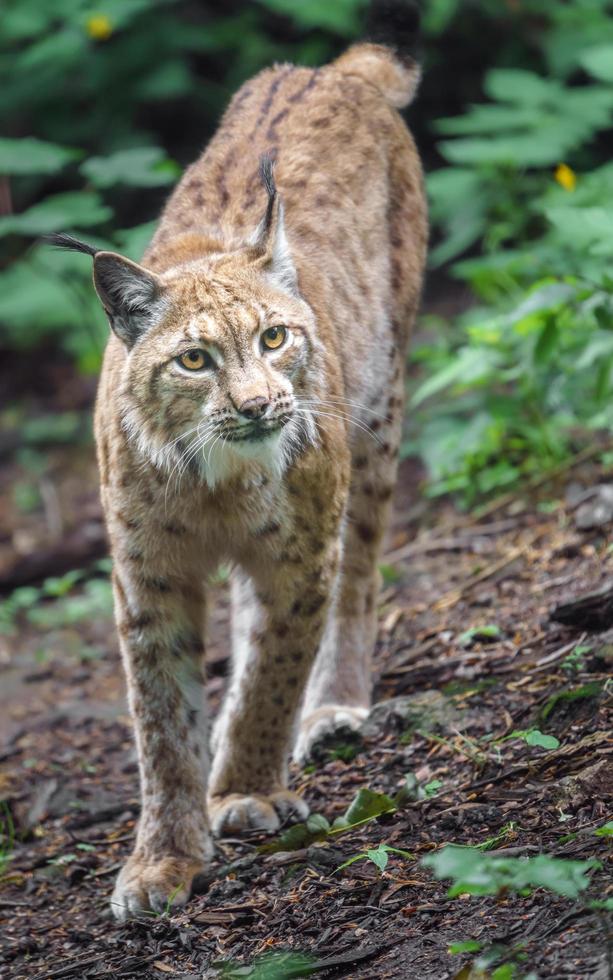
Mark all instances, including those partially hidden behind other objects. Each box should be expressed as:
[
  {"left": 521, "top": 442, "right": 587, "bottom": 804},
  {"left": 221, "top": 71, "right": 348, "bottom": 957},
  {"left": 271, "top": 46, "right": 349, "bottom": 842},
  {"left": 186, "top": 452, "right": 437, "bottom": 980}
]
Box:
[{"left": 0, "top": 354, "right": 613, "bottom": 980}]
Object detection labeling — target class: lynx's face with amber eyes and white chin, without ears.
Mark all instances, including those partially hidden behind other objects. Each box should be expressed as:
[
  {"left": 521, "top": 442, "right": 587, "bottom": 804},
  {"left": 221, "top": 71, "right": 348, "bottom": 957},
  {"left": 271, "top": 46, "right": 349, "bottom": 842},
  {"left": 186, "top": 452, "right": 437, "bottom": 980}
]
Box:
[{"left": 118, "top": 266, "right": 316, "bottom": 486}]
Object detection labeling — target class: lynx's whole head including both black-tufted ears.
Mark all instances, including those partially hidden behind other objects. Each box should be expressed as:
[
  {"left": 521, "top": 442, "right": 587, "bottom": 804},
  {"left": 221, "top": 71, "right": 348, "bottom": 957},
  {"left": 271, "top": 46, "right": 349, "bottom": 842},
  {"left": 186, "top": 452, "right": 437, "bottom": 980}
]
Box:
[{"left": 51, "top": 159, "right": 320, "bottom": 486}]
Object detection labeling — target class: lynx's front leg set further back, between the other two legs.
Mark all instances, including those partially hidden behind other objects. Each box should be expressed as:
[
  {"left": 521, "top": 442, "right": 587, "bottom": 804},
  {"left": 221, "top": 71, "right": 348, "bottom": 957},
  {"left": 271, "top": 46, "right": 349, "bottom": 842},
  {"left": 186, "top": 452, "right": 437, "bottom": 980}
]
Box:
[{"left": 209, "top": 539, "right": 339, "bottom": 834}]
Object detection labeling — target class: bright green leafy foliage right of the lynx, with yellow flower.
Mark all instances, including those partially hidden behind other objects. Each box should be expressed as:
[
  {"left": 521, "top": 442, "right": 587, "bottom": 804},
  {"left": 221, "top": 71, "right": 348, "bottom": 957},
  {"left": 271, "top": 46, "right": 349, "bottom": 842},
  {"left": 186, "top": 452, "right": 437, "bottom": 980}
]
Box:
[{"left": 405, "top": 0, "right": 613, "bottom": 505}]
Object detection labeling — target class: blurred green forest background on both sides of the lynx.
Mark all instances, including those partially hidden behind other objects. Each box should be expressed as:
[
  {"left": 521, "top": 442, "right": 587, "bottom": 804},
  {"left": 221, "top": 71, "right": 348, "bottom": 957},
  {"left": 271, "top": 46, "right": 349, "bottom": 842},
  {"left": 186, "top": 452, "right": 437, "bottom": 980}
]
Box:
[{"left": 0, "top": 0, "right": 613, "bottom": 721}]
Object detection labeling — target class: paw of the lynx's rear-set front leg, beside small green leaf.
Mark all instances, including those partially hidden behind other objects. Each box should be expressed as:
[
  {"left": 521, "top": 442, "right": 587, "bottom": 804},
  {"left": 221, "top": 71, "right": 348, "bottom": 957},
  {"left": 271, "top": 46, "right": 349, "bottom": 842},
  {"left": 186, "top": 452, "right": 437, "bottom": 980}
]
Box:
[{"left": 209, "top": 789, "right": 309, "bottom": 837}]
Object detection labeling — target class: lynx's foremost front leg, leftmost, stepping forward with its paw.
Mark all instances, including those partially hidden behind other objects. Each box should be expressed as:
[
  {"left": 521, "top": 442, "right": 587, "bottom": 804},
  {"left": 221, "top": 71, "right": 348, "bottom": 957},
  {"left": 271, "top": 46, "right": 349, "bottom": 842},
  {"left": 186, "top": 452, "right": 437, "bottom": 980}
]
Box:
[{"left": 106, "top": 529, "right": 212, "bottom": 920}]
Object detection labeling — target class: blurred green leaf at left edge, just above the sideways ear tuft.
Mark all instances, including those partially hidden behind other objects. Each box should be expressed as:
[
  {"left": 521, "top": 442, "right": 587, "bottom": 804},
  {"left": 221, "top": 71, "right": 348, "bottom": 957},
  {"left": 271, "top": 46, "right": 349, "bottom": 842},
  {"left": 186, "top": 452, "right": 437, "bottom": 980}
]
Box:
[{"left": 0, "top": 191, "right": 113, "bottom": 236}]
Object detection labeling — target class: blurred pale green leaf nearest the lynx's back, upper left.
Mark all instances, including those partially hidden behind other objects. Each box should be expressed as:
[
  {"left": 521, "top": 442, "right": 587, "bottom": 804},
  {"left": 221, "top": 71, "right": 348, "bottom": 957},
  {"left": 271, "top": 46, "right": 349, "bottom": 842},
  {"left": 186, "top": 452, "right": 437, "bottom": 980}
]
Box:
[{"left": 80, "top": 146, "right": 181, "bottom": 189}]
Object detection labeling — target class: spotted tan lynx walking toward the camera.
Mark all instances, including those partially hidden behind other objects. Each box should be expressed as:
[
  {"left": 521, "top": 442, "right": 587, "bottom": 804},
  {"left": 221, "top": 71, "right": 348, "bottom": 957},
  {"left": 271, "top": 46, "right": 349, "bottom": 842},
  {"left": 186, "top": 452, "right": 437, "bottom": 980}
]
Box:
[{"left": 50, "top": 15, "right": 427, "bottom": 920}]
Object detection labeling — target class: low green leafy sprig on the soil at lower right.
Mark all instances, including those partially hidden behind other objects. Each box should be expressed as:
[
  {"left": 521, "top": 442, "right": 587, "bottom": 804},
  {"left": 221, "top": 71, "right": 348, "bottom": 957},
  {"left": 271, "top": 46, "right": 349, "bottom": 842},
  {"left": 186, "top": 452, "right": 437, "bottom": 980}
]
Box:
[{"left": 422, "top": 844, "right": 601, "bottom": 898}]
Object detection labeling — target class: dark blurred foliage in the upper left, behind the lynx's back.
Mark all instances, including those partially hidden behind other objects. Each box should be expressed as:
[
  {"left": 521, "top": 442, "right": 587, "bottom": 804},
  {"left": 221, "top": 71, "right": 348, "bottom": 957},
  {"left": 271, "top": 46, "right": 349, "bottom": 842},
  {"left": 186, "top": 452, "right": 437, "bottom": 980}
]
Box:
[{"left": 0, "top": 0, "right": 364, "bottom": 372}]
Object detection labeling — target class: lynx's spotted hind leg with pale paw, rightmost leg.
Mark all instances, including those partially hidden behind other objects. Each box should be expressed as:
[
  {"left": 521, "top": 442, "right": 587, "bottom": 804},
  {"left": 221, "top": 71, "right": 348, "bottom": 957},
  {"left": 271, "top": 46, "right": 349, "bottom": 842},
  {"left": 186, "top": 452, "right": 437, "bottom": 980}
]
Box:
[{"left": 294, "top": 376, "right": 404, "bottom": 763}]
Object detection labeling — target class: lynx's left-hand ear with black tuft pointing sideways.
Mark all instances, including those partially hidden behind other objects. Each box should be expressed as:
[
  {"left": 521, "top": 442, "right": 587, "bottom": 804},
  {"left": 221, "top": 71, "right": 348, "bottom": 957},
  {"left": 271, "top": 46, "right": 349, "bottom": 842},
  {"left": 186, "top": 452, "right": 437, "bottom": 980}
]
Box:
[{"left": 47, "top": 235, "right": 163, "bottom": 348}]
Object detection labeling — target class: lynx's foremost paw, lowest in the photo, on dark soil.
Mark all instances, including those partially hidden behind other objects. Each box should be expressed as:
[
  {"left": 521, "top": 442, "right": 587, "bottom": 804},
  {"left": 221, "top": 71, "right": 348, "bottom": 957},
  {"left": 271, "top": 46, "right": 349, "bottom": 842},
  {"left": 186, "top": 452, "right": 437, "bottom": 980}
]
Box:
[{"left": 111, "top": 854, "right": 203, "bottom": 922}]
